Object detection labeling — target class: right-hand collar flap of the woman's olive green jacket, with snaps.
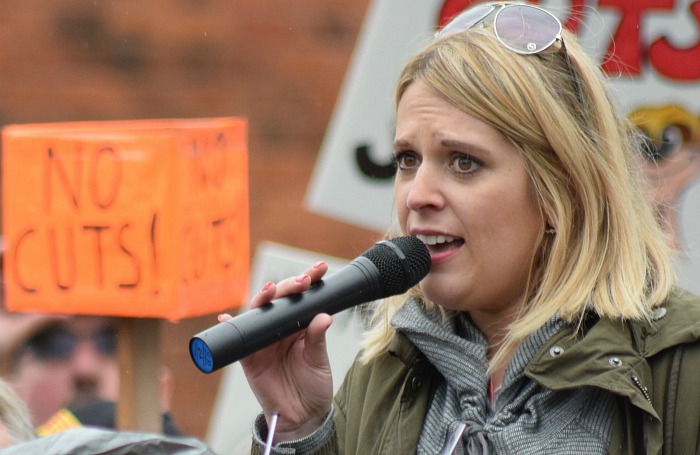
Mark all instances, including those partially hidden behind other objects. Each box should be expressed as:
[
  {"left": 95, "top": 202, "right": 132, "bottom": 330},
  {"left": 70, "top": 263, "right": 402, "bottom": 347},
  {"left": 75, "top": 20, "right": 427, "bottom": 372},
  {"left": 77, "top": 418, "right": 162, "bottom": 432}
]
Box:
[{"left": 526, "top": 290, "right": 700, "bottom": 419}]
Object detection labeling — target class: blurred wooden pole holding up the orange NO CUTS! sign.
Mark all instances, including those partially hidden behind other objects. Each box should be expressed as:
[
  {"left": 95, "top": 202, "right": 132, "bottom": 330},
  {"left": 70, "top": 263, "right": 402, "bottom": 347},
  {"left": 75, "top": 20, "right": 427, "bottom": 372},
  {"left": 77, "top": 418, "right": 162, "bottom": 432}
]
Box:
[{"left": 116, "top": 318, "right": 163, "bottom": 433}]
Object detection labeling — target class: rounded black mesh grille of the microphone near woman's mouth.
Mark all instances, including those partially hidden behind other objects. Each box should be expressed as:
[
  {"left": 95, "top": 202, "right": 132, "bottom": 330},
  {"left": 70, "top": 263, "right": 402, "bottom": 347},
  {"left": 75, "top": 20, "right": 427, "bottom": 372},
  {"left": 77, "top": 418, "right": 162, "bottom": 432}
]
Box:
[{"left": 362, "top": 236, "right": 431, "bottom": 298}]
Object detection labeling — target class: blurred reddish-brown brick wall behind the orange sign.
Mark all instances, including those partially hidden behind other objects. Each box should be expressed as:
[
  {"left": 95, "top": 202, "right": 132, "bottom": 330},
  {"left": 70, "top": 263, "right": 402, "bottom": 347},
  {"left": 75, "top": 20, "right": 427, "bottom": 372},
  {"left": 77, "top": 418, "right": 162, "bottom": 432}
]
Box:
[{"left": 0, "top": 0, "right": 378, "bottom": 437}]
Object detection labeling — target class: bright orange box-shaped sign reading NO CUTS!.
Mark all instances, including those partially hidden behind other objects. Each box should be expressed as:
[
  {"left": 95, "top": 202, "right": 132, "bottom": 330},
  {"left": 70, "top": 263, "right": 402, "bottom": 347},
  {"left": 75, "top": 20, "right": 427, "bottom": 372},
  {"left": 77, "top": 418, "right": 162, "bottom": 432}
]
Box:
[{"left": 2, "top": 118, "right": 250, "bottom": 319}]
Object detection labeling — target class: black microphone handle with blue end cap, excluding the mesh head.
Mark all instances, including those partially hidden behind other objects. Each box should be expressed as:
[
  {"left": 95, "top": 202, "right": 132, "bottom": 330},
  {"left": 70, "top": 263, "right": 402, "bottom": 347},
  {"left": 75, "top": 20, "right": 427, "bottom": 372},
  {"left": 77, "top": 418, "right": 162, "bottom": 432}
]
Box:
[{"left": 190, "top": 256, "right": 383, "bottom": 373}]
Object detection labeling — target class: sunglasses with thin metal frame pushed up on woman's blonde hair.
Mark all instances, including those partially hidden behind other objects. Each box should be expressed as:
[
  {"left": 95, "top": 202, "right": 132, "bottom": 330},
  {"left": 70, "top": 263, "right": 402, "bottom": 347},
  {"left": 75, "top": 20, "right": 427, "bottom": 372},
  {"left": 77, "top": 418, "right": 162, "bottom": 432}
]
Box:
[{"left": 435, "top": 2, "right": 583, "bottom": 104}]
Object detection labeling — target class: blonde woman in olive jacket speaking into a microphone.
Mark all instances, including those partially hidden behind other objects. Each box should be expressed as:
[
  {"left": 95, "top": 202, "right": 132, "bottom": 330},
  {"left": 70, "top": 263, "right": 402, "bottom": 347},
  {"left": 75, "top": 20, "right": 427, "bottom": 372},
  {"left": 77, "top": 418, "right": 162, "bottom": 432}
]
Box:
[{"left": 241, "top": 3, "right": 700, "bottom": 454}]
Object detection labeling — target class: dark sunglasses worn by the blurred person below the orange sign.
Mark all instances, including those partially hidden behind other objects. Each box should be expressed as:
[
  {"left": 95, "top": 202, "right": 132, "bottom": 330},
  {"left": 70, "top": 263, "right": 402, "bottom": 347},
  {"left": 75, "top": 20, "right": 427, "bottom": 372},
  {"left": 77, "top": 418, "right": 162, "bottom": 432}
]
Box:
[{"left": 25, "top": 327, "right": 117, "bottom": 360}]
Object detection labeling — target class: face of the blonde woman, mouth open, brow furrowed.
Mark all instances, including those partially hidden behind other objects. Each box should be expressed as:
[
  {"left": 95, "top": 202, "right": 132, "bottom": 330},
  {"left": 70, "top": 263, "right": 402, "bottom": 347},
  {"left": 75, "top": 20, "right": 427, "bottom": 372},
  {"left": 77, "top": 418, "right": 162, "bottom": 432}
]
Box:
[{"left": 394, "top": 82, "right": 545, "bottom": 330}]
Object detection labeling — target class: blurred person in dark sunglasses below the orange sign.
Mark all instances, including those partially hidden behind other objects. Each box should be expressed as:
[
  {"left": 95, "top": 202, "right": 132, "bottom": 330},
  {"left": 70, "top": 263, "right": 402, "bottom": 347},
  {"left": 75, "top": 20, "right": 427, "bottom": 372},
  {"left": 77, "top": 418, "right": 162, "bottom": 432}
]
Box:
[{"left": 0, "top": 240, "right": 180, "bottom": 436}]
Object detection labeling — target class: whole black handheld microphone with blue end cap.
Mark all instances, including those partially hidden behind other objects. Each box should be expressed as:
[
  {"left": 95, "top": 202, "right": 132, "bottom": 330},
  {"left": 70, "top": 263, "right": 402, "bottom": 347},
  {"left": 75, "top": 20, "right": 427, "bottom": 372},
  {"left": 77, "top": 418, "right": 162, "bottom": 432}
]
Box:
[{"left": 190, "top": 237, "right": 431, "bottom": 373}]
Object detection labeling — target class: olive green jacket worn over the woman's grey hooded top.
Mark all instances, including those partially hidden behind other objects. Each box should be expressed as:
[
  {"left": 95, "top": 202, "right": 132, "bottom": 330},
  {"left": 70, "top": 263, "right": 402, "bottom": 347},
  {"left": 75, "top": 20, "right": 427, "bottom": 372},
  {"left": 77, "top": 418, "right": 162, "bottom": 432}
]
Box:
[{"left": 254, "top": 291, "right": 700, "bottom": 455}]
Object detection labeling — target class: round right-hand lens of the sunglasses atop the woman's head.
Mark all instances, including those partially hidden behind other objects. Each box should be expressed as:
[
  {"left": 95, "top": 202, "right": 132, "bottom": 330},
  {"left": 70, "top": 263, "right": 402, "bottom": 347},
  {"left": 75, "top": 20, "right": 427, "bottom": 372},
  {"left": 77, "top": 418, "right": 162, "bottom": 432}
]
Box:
[{"left": 494, "top": 5, "right": 561, "bottom": 54}]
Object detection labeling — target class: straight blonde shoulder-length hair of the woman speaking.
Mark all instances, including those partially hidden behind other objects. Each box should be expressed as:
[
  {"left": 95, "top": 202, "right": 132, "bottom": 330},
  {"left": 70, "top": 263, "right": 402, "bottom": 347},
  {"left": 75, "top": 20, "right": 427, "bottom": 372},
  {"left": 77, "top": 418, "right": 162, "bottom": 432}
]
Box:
[{"left": 362, "top": 23, "right": 675, "bottom": 368}]
